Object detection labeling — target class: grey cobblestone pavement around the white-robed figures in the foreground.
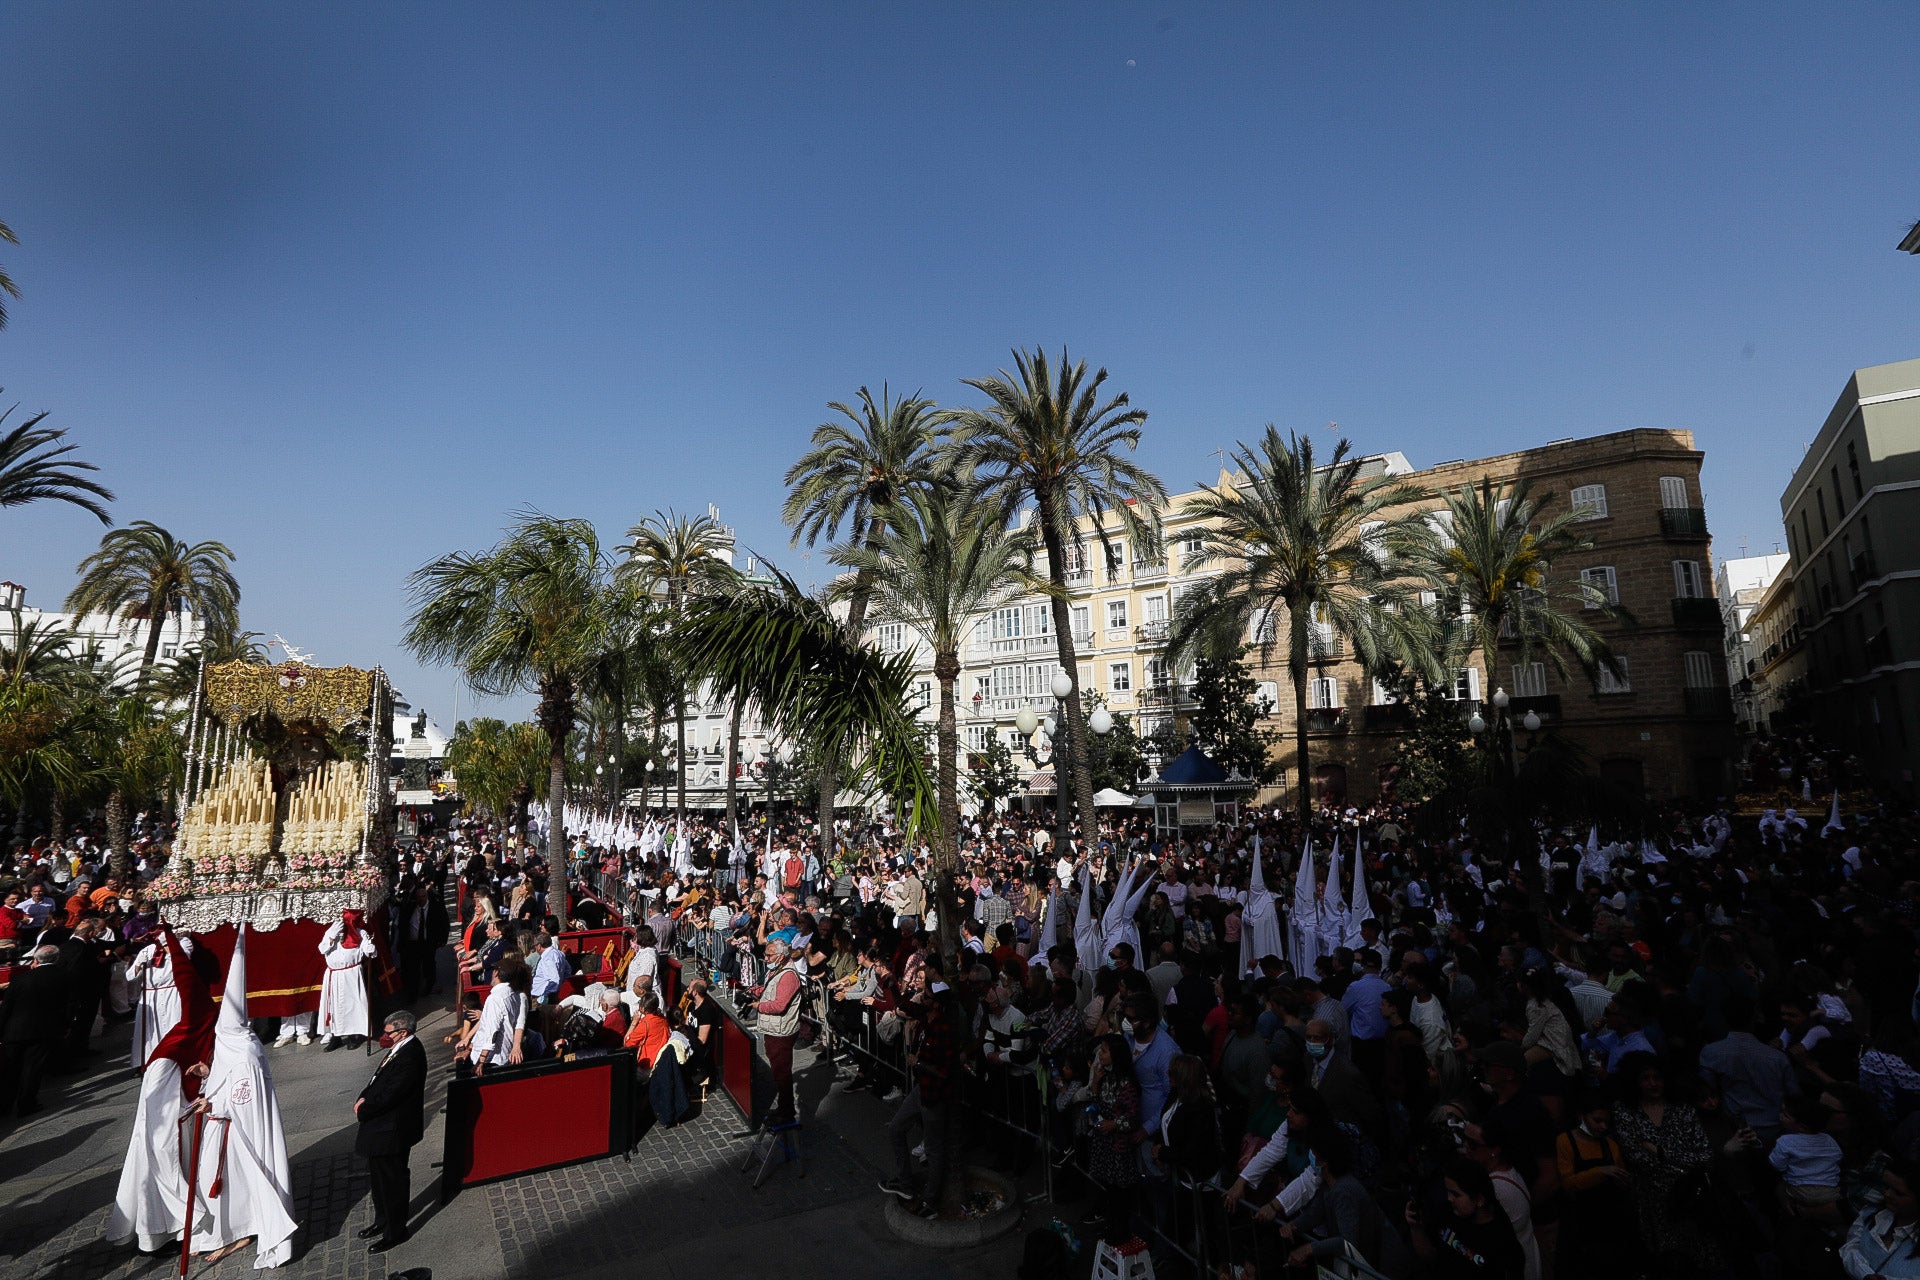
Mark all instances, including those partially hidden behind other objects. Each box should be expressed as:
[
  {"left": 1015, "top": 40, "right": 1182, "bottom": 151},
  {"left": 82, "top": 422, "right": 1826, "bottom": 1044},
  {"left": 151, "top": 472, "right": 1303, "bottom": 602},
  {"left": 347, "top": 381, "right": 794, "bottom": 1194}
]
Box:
[{"left": 0, "top": 967, "right": 1020, "bottom": 1280}]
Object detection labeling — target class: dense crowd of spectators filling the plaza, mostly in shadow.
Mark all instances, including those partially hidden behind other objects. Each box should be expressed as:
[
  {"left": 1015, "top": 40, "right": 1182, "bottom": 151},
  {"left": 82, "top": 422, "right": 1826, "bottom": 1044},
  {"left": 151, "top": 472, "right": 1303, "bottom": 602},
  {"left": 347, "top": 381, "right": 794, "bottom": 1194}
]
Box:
[{"left": 11, "top": 729, "right": 1920, "bottom": 1280}]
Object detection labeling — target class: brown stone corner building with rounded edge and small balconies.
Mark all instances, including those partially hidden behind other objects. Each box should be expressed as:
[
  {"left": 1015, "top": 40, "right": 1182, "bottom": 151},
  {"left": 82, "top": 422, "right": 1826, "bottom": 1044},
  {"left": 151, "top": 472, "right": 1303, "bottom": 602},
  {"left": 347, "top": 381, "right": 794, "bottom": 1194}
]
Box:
[{"left": 1261, "top": 428, "right": 1736, "bottom": 802}]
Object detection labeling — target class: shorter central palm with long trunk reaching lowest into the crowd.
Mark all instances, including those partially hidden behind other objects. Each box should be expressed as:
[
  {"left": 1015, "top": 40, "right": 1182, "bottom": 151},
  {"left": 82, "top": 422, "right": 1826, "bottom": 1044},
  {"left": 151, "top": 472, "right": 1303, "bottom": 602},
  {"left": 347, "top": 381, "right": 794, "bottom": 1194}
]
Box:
[{"left": 841, "top": 489, "right": 1044, "bottom": 956}]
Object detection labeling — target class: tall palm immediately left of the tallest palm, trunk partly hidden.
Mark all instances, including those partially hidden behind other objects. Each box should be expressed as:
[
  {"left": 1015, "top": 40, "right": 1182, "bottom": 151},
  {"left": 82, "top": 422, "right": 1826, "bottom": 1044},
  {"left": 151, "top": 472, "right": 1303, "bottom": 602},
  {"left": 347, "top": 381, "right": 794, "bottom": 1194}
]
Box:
[{"left": 780, "top": 384, "right": 945, "bottom": 865}]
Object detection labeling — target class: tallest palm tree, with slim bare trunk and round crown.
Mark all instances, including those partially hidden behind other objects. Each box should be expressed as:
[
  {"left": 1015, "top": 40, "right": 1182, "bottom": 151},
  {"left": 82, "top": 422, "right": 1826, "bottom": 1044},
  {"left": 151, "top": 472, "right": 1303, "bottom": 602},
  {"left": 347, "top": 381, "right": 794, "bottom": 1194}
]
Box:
[{"left": 952, "top": 349, "right": 1167, "bottom": 839}]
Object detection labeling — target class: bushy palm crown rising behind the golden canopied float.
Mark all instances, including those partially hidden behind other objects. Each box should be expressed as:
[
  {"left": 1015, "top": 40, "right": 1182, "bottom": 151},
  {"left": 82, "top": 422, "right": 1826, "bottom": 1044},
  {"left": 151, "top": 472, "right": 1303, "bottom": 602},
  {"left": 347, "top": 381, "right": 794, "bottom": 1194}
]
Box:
[{"left": 67, "top": 520, "right": 240, "bottom": 676}]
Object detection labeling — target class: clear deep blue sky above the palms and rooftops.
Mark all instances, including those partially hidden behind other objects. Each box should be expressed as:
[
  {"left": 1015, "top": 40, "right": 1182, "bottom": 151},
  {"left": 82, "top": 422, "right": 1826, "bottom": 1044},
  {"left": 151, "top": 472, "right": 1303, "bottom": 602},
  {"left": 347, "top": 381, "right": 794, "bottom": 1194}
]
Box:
[{"left": 0, "top": 0, "right": 1920, "bottom": 727}]
